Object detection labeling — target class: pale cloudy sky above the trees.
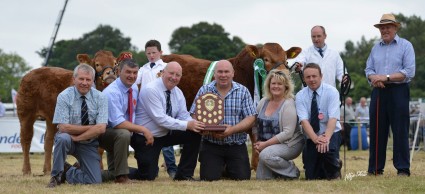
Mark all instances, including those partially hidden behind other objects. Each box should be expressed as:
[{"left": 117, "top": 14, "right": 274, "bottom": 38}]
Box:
[{"left": 0, "top": 0, "right": 425, "bottom": 68}]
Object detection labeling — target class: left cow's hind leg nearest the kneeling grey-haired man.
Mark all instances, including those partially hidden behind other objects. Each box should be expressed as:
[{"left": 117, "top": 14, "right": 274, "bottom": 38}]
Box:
[{"left": 43, "top": 118, "right": 57, "bottom": 175}]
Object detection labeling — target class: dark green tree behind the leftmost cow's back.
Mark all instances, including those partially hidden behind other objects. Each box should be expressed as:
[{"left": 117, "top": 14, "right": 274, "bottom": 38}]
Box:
[{"left": 37, "top": 25, "right": 137, "bottom": 70}]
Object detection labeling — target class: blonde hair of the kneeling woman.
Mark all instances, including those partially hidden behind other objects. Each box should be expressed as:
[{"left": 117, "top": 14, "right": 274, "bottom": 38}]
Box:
[{"left": 264, "top": 69, "right": 294, "bottom": 100}]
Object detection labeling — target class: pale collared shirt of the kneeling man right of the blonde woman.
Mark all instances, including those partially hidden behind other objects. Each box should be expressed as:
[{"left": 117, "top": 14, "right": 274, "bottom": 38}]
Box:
[{"left": 296, "top": 83, "right": 341, "bottom": 134}]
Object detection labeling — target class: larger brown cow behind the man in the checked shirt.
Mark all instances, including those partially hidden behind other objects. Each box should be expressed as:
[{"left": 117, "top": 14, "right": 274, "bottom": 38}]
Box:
[{"left": 162, "top": 43, "right": 301, "bottom": 169}]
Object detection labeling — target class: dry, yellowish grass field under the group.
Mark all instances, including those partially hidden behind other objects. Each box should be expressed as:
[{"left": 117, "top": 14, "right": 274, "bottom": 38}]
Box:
[{"left": 0, "top": 146, "right": 425, "bottom": 193}]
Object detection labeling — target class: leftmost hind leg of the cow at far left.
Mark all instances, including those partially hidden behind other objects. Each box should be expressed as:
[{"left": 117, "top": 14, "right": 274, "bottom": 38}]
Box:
[{"left": 19, "top": 114, "right": 35, "bottom": 175}]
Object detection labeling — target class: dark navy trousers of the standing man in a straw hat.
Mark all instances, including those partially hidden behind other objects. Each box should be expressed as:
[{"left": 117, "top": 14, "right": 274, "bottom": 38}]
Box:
[{"left": 368, "top": 84, "right": 410, "bottom": 174}]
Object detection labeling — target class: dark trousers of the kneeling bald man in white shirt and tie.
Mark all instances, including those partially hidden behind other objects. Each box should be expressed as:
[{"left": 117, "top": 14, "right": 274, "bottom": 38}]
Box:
[{"left": 129, "top": 130, "right": 201, "bottom": 180}]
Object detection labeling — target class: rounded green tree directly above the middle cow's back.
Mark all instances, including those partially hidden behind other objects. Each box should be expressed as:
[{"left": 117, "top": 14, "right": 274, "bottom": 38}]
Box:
[{"left": 168, "top": 22, "right": 245, "bottom": 60}]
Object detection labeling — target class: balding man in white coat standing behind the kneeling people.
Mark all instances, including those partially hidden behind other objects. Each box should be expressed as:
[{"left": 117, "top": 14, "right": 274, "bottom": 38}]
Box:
[{"left": 295, "top": 26, "right": 344, "bottom": 87}]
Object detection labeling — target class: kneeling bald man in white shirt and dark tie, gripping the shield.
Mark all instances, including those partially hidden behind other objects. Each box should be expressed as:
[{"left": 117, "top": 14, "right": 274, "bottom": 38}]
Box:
[{"left": 130, "top": 62, "right": 205, "bottom": 181}]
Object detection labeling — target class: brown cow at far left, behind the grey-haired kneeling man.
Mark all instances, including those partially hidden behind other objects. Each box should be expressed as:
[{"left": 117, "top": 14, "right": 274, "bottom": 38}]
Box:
[{"left": 16, "top": 50, "right": 116, "bottom": 175}]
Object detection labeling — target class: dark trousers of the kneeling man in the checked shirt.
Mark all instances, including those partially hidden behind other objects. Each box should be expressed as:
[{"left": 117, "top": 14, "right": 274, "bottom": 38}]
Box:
[{"left": 199, "top": 140, "right": 251, "bottom": 181}]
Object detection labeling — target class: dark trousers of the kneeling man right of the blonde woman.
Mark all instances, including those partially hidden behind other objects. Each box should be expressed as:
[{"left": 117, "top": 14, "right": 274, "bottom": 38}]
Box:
[{"left": 303, "top": 132, "right": 341, "bottom": 180}]
